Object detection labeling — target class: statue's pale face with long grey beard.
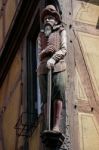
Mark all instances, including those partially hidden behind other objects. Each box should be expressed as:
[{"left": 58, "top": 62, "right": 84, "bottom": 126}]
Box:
[{"left": 44, "top": 15, "right": 58, "bottom": 37}]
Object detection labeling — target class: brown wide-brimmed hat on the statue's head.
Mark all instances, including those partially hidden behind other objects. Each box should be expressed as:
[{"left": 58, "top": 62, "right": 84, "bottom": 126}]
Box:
[{"left": 41, "top": 5, "right": 61, "bottom": 23}]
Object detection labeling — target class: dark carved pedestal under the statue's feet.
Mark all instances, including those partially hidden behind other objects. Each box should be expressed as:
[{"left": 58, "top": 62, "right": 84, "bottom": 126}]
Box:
[{"left": 41, "top": 130, "right": 65, "bottom": 148}]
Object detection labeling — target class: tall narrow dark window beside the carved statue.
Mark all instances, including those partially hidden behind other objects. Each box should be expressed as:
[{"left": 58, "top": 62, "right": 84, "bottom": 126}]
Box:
[{"left": 26, "top": 13, "right": 40, "bottom": 132}]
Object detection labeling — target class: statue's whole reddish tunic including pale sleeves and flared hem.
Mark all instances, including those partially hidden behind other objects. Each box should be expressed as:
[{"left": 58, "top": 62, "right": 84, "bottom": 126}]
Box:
[{"left": 37, "top": 27, "right": 67, "bottom": 74}]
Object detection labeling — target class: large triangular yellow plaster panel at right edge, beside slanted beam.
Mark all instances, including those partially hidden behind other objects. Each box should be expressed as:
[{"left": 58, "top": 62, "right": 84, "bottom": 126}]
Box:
[{"left": 79, "top": 33, "right": 99, "bottom": 102}]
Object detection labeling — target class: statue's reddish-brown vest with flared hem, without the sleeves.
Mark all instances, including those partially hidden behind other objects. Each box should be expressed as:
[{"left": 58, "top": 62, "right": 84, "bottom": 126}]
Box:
[{"left": 37, "top": 29, "right": 66, "bottom": 74}]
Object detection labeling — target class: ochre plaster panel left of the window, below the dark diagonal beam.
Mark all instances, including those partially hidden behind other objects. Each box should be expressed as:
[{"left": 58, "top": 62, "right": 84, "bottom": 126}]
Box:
[{"left": 0, "top": 51, "right": 21, "bottom": 150}]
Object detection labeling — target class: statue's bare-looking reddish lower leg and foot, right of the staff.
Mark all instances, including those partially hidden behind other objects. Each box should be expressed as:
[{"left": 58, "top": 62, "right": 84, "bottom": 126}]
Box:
[{"left": 53, "top": 100, "right": 63, "bottom": 132}]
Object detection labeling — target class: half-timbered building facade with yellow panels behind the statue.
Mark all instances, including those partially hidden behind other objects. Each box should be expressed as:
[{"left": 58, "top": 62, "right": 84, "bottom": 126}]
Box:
[{"left": 0, "top": 0, "right": 99, "bottom": 150}]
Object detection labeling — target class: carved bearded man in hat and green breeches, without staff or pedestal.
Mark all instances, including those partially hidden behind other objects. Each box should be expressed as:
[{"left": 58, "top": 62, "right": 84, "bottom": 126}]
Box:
[{"left": 38, "top": 5, "right": 67, "bottom": 132}]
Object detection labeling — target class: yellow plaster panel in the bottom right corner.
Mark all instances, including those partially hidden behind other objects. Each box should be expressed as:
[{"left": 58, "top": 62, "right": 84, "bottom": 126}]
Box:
[{"left": 79, "top": 113, "right": 99, "bottom": 150}]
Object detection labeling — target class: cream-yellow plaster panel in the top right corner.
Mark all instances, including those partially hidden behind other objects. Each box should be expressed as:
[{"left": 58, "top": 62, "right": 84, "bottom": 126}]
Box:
[{"left": 75, "top": 0, "right": 99, "bottom": 25}]
